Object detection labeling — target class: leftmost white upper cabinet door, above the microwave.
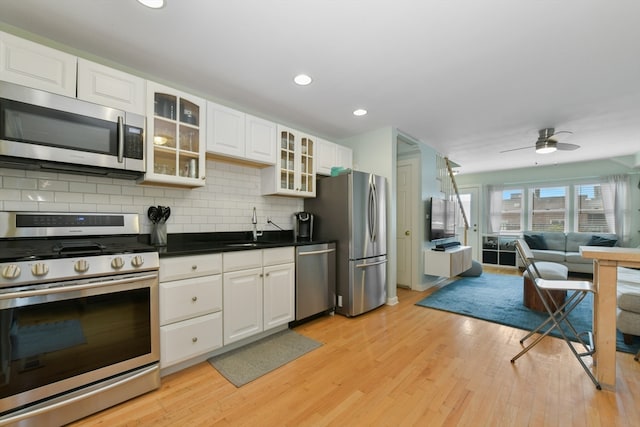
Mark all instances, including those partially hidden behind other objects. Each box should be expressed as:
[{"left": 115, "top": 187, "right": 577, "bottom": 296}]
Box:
[{"left": 0, "top": 32, "right": 77, "bottom": 98}]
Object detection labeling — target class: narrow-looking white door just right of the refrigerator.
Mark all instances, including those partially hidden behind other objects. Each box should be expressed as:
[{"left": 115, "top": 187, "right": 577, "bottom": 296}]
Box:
[{"left": 396, "top": 161, "right": 414, "bottom": 288}]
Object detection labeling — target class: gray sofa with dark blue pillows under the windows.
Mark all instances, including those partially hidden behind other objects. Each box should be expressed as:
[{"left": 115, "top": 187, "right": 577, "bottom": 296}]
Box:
[{"left": 518, "top": 231, "right": 618, "bottom": 274}]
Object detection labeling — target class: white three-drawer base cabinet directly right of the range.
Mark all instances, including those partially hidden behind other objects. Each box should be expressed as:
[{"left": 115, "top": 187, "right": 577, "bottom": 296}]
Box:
[{"left": 160, "top": 254, "right": 223, "bottom": 368}]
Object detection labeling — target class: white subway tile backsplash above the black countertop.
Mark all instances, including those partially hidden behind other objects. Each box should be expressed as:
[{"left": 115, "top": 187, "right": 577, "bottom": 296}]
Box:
[{"left": 0, "top": 160, "right": 303, "bottom": 234}]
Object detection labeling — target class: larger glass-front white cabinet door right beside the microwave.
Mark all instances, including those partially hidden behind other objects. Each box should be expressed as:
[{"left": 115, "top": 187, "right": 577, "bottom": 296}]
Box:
[{"left": 142, "top": 82, "right": 206, "bottom": 187}]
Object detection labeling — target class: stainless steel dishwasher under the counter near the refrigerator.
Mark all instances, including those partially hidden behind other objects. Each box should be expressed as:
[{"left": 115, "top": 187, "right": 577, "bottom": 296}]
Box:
[{"left": 296, "top": 243, "right": 336, "bottom": 322}]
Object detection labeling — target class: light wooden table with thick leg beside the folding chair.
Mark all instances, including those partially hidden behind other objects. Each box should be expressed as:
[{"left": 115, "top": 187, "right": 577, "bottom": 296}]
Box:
[{"left": 580, "top": 246, "right": 640, "bottom": 390}]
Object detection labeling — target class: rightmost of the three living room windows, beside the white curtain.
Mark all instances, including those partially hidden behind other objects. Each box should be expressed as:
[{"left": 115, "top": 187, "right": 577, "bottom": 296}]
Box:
[{"left": 575, "top": 184, "right": 613, "bottom": 233}]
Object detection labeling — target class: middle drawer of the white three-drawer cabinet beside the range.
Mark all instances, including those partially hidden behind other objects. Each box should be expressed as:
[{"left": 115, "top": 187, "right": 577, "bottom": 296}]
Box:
[{"left": 160, "top": 274, "right": 222, "bottom": 325}]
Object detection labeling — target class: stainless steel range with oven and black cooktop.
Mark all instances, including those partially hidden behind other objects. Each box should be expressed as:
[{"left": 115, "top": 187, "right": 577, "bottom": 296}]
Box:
[{"left": 0, "top": 212, "right": 160, "bottom": 426}]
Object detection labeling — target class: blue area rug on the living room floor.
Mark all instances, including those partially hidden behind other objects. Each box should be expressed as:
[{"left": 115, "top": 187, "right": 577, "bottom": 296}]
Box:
[{"left": 416, "top": 273, "right": 640, "bottom": 354}]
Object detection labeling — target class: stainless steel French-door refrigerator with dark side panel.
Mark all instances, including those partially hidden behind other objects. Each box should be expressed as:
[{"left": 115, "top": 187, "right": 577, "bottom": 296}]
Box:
[{"left": 304, "top": 171, "right": 387, "bottom": 316}]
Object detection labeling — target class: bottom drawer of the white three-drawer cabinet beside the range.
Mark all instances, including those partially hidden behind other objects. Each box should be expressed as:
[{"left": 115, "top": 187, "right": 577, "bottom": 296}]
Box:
[{"left": 160, "top": 312, "right": 222, "bottom": 368}]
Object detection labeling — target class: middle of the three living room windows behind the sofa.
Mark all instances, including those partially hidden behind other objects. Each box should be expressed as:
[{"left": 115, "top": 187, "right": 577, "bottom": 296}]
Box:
[{"left": 529, "top": 187, "right": 568, "bottom": 231}]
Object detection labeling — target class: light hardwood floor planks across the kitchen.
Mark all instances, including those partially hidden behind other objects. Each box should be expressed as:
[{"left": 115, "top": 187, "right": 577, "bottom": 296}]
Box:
[{"left": 74, "top": 272, "right": 640, "bottom": 427}]
